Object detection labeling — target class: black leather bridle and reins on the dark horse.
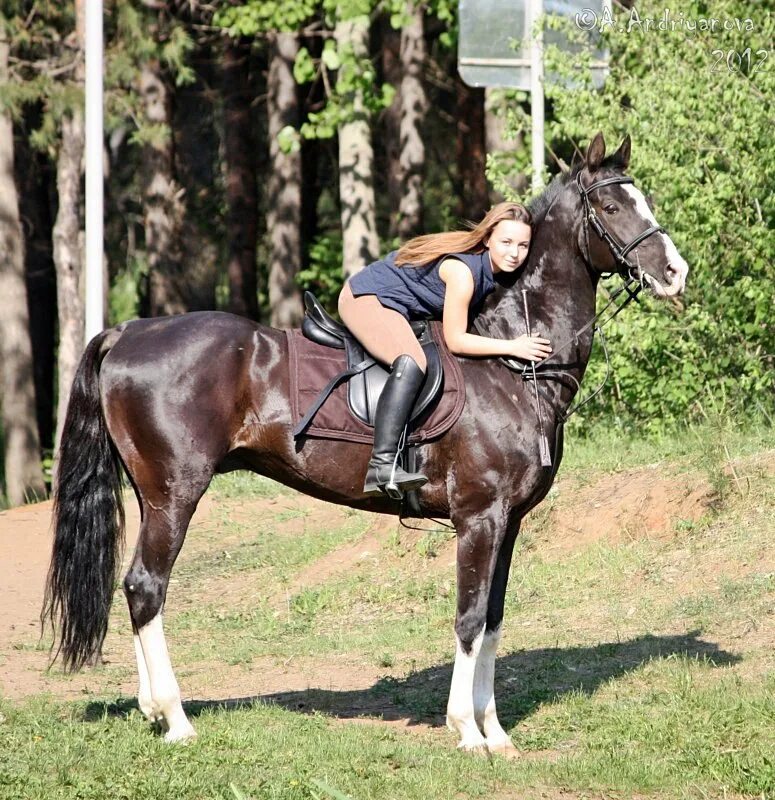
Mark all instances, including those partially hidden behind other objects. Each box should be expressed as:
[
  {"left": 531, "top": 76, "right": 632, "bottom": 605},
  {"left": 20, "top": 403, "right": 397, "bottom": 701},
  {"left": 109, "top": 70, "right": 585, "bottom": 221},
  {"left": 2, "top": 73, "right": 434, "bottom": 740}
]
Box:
[{"left": 492, "top": 170, "right": 666, "bottom": 427}]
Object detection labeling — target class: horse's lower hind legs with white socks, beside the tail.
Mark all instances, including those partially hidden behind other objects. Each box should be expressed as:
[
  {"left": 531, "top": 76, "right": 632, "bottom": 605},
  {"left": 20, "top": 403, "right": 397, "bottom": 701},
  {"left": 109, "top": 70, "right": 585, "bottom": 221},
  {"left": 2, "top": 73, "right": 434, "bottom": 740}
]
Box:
[{"left": 124, "top": 498, "right": 203, "bottom": 742}]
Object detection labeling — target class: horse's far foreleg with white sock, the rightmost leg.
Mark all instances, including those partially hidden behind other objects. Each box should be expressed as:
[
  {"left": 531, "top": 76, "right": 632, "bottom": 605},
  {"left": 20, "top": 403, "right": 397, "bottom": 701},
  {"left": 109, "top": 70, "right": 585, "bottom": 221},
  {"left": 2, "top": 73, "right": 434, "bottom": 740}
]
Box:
[{"left": 474, "top": 523, "right": 519, "bottom": 756}]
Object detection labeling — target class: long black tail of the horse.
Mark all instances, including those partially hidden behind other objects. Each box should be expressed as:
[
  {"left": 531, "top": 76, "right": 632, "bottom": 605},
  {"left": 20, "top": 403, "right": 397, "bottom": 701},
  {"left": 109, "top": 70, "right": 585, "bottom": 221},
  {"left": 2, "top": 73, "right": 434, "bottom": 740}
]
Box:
[{"left": 41, "top": 331, "right": 124, "bottom": 671}]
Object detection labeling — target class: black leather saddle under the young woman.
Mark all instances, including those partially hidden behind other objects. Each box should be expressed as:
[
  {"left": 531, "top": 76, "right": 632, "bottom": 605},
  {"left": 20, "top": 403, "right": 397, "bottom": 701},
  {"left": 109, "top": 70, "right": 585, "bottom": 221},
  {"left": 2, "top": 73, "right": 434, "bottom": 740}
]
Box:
[{"left": 294, "top": 292, "right": 444, "bottom": 436}]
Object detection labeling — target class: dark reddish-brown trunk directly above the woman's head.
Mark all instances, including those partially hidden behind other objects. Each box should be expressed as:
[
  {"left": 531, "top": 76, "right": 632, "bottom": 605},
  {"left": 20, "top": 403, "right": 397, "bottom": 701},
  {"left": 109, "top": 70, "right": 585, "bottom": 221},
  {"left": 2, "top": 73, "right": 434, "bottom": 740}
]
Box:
[{"left": 455, "top": 75, "right": 490, "bottom": 222}]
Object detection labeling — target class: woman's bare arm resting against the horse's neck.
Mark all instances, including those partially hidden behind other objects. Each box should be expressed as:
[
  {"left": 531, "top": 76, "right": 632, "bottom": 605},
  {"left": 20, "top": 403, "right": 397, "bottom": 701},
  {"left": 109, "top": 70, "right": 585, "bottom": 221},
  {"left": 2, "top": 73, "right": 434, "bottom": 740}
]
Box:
[{"left": 439, "top": 258, "right": 552, "bottom": 361}]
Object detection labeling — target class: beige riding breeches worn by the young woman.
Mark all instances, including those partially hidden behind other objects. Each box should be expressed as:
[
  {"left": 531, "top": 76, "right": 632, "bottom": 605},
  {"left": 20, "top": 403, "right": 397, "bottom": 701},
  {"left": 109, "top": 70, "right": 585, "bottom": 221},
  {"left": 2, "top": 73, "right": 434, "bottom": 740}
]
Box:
[{"left": 339, "top": 283, "right": 426, "bottom": 372}]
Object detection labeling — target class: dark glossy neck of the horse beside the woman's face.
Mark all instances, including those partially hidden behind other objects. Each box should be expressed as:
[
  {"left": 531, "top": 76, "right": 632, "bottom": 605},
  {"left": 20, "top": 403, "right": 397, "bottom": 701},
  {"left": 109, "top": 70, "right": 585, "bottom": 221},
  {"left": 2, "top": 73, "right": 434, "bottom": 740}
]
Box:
[{"left": 479, "top": 193, "right": 597, "bottom": 407}]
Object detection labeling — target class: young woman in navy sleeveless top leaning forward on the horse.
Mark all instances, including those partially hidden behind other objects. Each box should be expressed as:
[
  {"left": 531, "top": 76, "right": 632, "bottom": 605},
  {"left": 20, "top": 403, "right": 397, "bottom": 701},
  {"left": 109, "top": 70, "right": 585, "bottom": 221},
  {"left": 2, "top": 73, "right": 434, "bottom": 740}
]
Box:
[{"left": 339, "top": 203, "right": 551, "bottom": 495}]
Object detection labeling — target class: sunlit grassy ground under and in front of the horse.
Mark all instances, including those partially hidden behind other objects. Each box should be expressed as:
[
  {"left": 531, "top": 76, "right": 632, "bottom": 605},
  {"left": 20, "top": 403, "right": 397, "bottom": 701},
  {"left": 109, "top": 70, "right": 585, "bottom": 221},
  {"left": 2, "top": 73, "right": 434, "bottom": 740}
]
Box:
[{"left": 7, "top": 422, "right": 775, "bottom": 800}]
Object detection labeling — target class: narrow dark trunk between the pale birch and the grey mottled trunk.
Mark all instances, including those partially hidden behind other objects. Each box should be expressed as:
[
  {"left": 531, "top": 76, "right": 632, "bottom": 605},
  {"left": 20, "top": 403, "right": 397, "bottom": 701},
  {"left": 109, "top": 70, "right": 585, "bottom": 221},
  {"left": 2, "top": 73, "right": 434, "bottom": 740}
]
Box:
[{"left": 382, "top": 14, "right": 403, "bottom": 239}]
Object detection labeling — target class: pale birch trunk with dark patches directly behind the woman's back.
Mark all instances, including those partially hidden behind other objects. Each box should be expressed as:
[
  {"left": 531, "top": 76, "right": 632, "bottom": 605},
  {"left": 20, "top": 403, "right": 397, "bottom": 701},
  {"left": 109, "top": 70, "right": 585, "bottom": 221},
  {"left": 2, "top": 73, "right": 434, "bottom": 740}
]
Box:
[{"left": 334, "top": 16, "right": 379, "bottom": 277}]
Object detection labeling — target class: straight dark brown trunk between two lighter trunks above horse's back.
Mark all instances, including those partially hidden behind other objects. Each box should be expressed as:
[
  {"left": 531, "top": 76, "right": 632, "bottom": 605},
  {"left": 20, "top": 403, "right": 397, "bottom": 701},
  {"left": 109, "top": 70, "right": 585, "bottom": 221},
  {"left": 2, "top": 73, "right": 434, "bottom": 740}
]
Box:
[{"left": 223, "top": 40, "right": 260, "bottom": 320}]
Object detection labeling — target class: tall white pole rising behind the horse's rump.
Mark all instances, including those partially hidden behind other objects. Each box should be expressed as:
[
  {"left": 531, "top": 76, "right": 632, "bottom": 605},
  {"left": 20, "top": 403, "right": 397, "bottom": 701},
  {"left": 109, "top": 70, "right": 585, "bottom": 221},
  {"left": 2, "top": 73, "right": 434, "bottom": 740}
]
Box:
[{"left": 85, "top": 0, "right": 105, "bottom": 342}]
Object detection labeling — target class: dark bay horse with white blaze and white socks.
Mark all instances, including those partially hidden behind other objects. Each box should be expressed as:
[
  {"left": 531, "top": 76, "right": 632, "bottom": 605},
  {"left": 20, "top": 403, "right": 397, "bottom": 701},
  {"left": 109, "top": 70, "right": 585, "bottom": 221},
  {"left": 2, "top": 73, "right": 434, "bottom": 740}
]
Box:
[{"left": 43, "top": 134, "right": 688, "bottom": 754}]
